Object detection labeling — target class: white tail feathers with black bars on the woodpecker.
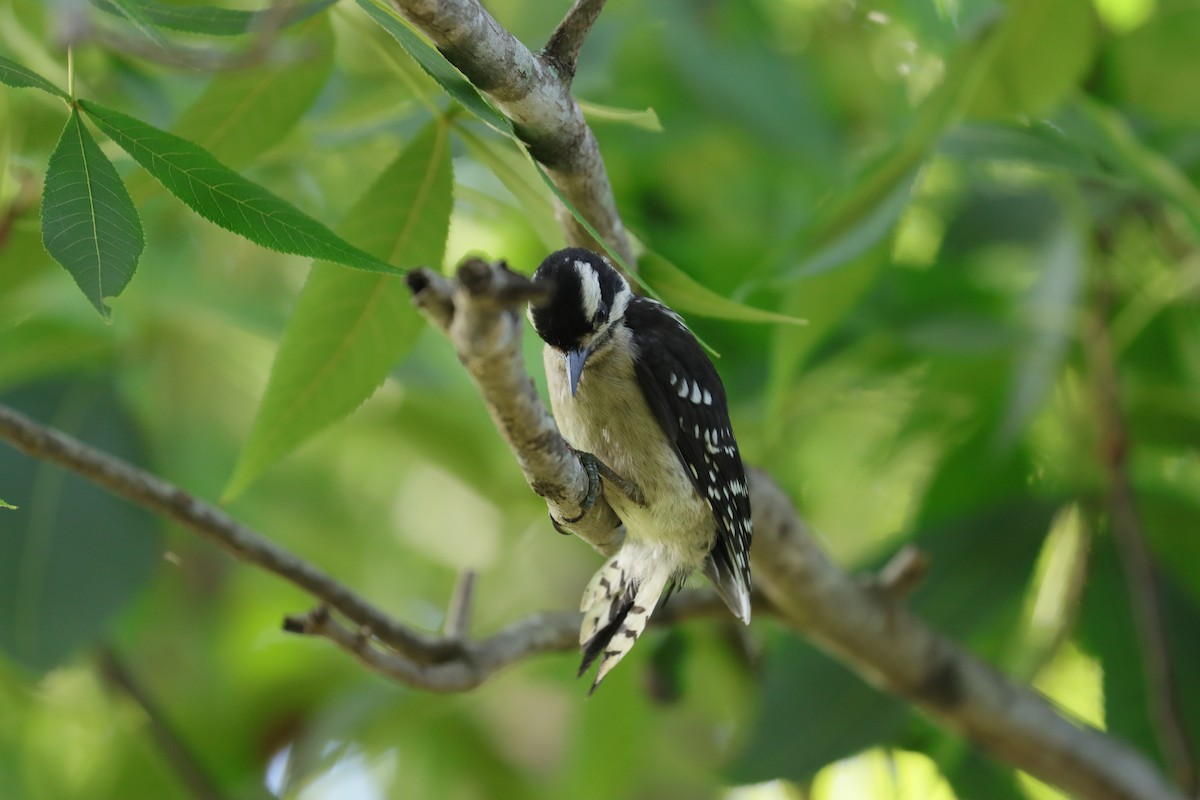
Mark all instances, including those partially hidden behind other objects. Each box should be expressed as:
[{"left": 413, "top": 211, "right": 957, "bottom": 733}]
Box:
[{"left": 580, "top": 551, "right": 671, "bottom": 692}]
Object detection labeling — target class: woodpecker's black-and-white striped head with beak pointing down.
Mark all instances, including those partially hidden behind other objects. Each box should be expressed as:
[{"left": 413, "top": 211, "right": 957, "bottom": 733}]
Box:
[{"left": 529, "top": 247, "right": 632, "bottom": 396}]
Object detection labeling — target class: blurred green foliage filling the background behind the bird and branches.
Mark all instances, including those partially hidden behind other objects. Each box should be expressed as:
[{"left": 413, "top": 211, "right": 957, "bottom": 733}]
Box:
[{"left": 0, "top": 0, "right": 1200, "bottom": 800}]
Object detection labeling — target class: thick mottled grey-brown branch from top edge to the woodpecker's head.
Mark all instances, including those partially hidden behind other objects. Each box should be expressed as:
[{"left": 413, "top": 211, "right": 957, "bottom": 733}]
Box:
[{"left": 392, "top": 0, "right": 634, "bottom": 264}]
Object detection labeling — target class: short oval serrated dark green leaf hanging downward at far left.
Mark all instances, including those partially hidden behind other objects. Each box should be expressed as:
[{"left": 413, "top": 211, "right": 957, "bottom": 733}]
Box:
[{"left": 42, "top": 109, "right": 145, "bottom": 317}]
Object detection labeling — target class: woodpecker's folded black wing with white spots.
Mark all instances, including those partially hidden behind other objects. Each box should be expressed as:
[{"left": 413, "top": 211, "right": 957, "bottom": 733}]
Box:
[{"left": 625, "top": 297, "right": 754, "bottom": 616}]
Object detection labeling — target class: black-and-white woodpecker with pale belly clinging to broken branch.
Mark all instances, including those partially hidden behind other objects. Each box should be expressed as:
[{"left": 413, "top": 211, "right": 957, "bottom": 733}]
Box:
[{"left": 529, "top": 247, "right": 754, "bottom": 691}]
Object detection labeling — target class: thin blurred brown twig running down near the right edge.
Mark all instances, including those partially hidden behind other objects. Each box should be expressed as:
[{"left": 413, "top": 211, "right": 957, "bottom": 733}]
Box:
[{"left": 1088, "top": 289, "right": 1200, "bottom": 796}]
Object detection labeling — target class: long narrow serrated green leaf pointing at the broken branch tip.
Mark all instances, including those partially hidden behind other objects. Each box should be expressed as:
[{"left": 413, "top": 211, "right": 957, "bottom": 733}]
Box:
[{"left": 79, "top": 101, "right": 403, "bottom": 275}]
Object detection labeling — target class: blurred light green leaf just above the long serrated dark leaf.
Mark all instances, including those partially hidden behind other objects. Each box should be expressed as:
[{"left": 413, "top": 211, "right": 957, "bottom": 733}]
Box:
[{"left": 170, "top": 17, "right": 334, "bottom": 169}]
